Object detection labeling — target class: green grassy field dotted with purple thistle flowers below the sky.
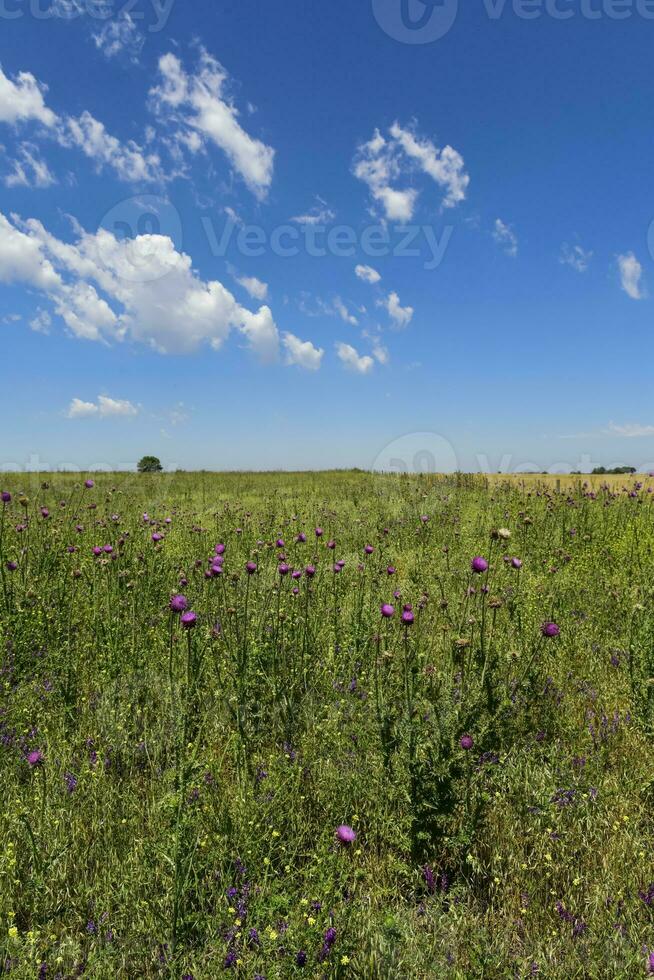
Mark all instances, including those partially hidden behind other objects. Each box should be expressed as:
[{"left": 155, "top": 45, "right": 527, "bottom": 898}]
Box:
[{"left": 0, "top": 472, "right": 654, "bottom": 980}]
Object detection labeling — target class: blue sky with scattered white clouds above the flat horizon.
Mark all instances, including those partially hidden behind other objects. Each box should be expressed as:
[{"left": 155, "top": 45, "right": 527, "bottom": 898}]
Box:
[{"left": 0, "top": 0, "right": 654, "bottom": 470}]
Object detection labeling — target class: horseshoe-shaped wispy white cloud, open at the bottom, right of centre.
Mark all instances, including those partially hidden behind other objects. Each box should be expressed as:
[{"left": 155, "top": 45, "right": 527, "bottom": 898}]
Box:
[{"left": 354, "top": 122, "right": 470, "bottom": 222}]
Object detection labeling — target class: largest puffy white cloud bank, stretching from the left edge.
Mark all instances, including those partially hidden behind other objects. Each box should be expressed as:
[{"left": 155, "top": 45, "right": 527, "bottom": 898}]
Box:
[{"left": 0, "top": 214, "right": 322, "bottom": 362}]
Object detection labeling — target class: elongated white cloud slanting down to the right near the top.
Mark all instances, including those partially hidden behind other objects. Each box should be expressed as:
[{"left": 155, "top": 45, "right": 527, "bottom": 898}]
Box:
[{"left": 150, "top": 50, "right": 275, "bottom": 199}]
